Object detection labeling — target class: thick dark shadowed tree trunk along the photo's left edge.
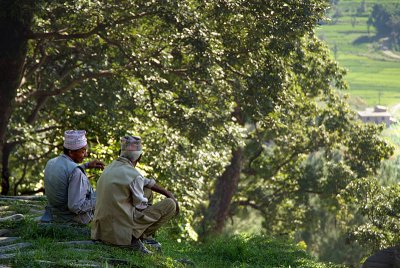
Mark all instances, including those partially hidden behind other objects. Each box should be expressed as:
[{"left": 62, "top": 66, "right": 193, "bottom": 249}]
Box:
[{"left": 0, "top": 0, "right": 34, "bottom": 194}]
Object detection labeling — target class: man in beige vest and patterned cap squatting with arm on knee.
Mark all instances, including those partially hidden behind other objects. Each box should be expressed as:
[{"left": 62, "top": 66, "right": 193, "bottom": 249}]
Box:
[{"left": 92, "top": 136, "right": 179, "bottom": 253}]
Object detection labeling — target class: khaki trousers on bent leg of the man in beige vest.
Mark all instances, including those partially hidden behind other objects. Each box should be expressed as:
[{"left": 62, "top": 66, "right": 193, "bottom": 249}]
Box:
[{"left": 133, "top": 188, "right": 176, "bottom": 238}]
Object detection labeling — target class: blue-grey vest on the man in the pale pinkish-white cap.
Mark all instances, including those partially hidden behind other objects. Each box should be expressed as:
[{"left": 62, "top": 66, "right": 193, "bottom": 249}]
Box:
[{"left": 44, "top": 154, "right": 85, "bottom": 222}]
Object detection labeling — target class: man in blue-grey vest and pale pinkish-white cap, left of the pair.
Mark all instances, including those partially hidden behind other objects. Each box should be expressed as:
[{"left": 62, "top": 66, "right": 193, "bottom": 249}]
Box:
[{"left": 41, "top": 130, "right": 104, "bottom": 224}]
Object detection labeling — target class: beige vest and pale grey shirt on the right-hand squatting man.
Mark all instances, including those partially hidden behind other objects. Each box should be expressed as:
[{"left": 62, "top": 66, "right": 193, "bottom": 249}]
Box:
[{"left": 92, "top": 157, "right": 158, "bottom": 245}]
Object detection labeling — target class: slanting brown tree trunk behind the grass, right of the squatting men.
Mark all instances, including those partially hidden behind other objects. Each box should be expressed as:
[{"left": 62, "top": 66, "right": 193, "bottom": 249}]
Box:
[{"left": 200, "top": 147, "right": 243, "bottom": 237}]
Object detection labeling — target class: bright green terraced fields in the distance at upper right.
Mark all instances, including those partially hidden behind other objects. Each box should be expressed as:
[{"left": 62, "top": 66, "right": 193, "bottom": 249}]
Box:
[{"left": 317, "top": 0, "right": 400, "bottom": 108}]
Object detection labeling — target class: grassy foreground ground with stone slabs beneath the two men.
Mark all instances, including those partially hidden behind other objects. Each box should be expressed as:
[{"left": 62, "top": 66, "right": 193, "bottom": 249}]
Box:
[{"left": 0, "top": 196, "right": 337, "bottom": 268}]
